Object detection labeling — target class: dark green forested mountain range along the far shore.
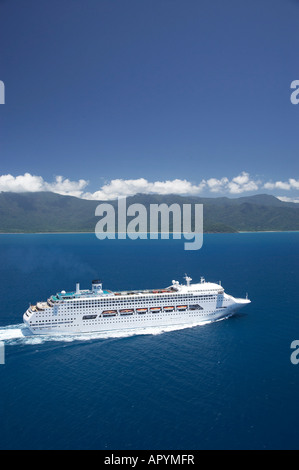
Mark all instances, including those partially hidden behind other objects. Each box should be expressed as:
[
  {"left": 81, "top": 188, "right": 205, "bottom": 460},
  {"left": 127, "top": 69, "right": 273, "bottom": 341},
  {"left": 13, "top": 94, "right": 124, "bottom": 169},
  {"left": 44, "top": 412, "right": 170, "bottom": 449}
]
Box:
[{"left": 0, "top": 192, "right": 299, "bottom": 233}]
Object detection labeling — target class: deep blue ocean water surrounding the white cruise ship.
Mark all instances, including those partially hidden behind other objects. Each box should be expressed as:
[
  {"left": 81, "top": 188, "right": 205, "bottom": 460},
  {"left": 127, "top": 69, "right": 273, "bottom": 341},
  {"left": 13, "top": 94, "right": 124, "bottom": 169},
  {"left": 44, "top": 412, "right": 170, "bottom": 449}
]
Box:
[{"left": 0, "top": 233, "right": 299, "bottom": 450}]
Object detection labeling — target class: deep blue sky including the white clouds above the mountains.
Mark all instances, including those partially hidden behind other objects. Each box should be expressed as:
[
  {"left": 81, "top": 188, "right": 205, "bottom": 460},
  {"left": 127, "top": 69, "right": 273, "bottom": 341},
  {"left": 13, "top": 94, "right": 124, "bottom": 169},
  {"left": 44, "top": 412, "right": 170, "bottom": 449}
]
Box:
[{"left": 0, "top": 0, "right": 299, "bottom": 199}]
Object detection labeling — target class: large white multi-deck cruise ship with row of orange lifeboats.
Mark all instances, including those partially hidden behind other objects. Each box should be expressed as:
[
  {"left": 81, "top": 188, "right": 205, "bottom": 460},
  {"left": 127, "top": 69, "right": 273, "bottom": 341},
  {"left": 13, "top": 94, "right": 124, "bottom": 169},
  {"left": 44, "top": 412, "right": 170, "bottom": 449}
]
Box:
[{"left": 23, "top": 275, "right": 251, "bottom": 335}]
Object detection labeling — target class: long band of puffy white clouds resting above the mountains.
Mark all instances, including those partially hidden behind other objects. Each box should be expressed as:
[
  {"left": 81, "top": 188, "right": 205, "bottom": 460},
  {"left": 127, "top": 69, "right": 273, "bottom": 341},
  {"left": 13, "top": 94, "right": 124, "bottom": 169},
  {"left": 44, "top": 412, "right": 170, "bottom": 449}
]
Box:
[{"left": 0, "top": 171, "right": 299, "bottom": 202}]
